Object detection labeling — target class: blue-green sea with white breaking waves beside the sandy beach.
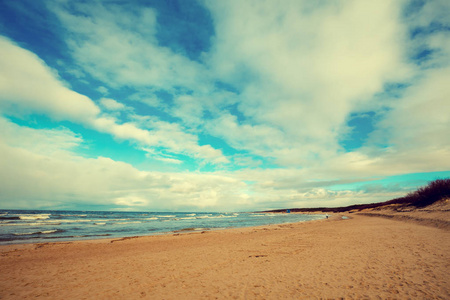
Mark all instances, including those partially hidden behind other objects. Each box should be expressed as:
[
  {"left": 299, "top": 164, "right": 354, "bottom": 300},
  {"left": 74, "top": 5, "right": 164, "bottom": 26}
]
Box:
[{"left": 0, "top": 210, "right": 325, "bottom": 245}]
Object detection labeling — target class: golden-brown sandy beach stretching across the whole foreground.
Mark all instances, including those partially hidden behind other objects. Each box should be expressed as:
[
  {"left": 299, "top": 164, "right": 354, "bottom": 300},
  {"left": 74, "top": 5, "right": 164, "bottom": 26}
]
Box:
[{"left": 0, "top": 214, "right": 450, "bottom": 299}]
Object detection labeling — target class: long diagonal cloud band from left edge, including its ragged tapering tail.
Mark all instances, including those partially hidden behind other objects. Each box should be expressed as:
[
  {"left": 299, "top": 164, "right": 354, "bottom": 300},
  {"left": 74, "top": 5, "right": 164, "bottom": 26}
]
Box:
[{"left": 0, "top": 38, "right": 228, "bottom": 163}]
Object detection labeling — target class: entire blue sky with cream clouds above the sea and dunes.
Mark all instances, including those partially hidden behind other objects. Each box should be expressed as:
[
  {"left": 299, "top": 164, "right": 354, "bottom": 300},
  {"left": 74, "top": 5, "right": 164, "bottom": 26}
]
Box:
[{"left": 0, "top": 0, "right": 450, "bottom": 211}]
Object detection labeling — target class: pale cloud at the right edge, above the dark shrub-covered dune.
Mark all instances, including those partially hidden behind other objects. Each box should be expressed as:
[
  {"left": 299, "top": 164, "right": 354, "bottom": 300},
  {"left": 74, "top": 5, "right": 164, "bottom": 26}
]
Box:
[{"left": 376, "top": 67, "right": 450, "bottom": 152}]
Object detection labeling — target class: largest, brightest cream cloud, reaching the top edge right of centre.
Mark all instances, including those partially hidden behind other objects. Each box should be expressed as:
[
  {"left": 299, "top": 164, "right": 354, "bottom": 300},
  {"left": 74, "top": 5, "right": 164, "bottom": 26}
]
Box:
[{"left": 202, "top": 1, "right": 411, "bottom": 165}]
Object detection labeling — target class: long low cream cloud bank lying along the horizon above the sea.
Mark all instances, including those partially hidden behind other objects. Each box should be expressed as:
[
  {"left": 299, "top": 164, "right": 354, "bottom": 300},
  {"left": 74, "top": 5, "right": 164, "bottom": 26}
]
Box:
[{"left": 0, "top": 115, "right": 436, "bottom": 211}]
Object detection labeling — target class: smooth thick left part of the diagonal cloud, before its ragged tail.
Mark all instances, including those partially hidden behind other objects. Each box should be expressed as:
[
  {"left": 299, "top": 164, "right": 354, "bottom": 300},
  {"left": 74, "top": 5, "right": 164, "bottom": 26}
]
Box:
[{"left": 0, "top": 36, "right": 100, "bottom": 123}]
